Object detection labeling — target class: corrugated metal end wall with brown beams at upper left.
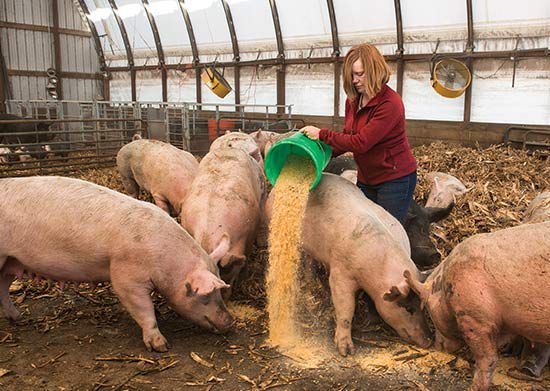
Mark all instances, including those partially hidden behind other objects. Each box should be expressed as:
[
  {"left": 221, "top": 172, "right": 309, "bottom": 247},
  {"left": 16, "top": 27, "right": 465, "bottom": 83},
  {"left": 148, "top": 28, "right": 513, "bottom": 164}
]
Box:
[{"left": 0, "top": 0, "right": 103, "bottom": 100}]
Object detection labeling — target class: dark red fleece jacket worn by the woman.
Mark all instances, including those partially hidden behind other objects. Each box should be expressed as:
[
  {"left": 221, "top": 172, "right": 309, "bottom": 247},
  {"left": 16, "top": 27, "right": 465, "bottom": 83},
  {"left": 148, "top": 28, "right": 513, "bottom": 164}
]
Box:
[{"left": 319, "top": 84, "right": 416, "bottom": 185}]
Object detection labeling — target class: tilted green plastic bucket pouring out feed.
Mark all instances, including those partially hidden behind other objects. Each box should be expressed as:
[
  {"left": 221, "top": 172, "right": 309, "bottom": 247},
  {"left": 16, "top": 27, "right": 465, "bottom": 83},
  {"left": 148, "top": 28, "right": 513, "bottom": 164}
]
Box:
[{"left": 264, "top": 132, "right": 332, "bottom": 190}]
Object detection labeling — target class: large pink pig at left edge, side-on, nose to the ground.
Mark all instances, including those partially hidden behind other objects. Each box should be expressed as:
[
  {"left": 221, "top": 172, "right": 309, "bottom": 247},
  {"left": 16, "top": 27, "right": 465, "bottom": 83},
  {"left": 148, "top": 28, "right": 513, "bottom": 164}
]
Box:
[{"left": 0, "top": 176, "right": 233, "bottom": 351}]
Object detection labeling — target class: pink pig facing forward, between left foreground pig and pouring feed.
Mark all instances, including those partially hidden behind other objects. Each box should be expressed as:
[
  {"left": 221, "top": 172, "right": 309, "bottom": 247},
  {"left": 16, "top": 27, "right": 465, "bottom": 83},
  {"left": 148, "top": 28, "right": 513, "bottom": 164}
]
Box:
[{"left": 181, "top": 148, "right": 266, "bottom": 297}]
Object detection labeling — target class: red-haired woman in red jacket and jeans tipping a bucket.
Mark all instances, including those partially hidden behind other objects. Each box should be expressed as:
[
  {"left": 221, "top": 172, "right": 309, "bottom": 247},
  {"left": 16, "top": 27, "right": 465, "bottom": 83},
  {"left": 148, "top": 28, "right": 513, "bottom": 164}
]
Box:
[{"left": 300, "top": 44, "right": 416, "bottom": 224}]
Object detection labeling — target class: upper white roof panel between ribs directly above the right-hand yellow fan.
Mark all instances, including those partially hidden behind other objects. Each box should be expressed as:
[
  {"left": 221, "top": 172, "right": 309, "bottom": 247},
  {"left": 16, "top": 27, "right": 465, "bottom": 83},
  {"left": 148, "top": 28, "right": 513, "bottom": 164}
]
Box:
[{"left": 401, "top": 0, "right": 468, "bottom": 53}]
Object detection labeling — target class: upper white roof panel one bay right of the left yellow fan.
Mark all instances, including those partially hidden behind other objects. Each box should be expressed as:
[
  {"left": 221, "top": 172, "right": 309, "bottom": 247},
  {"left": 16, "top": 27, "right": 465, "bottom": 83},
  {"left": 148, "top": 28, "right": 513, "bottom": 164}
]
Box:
[{"left": 227, "top": 0, "right": 277, "bottom": 51}]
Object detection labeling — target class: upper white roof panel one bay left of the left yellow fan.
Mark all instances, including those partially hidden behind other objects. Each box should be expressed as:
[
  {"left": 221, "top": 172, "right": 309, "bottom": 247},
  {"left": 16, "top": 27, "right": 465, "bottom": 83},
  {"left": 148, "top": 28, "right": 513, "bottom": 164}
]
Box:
[{"left": 149, "top": 0, "right": 191, "bottom": 57}]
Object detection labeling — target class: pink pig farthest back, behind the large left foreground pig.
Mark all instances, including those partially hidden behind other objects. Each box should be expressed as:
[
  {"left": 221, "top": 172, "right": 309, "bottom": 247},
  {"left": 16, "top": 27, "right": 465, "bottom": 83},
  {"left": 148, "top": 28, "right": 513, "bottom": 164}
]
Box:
[{"left": 116, "top": 139, "right": 199, "bottom": 215}]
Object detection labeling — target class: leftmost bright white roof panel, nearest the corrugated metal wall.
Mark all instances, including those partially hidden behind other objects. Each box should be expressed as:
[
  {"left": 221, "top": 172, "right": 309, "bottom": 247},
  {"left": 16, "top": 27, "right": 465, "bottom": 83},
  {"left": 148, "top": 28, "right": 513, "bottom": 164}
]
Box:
[{"left": 85, "top": 0, "right": 126, "bottom": 58}]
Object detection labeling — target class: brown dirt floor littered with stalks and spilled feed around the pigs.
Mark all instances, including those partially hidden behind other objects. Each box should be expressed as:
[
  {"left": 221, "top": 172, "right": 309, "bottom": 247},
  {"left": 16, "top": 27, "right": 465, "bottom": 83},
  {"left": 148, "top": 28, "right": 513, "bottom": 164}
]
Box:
[{"left": 0, "top": 146, "right": 550, "bottom": 391}]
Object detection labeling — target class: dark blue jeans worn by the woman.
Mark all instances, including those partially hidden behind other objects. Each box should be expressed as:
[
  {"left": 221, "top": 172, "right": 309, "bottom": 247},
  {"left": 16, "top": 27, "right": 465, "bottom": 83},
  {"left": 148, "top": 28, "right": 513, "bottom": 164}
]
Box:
[{"left": 357, "top": 171, "right": 416, "bottom": 225}]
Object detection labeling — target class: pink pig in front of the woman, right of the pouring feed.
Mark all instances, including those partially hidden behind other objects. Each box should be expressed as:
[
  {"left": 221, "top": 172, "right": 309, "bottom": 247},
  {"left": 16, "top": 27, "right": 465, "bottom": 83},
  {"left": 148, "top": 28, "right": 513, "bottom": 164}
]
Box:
[{"left": 266, "top": 173, "right": 431, "bottom": 356}]
